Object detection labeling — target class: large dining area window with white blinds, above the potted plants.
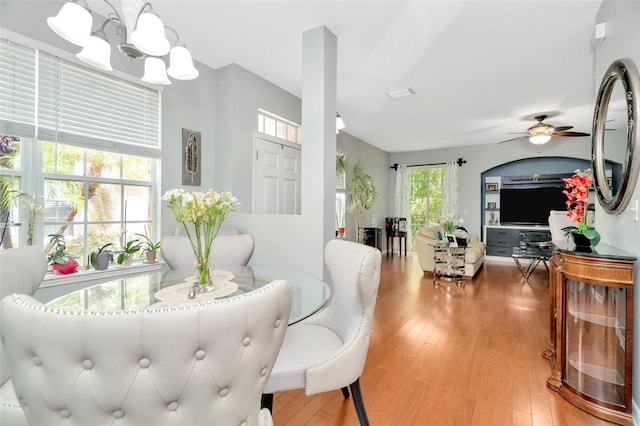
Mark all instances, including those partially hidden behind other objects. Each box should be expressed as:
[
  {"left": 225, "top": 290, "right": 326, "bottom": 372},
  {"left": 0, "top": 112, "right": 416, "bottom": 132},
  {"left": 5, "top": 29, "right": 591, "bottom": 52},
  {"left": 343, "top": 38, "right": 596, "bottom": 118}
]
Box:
[{"left": 0, "top": 40, "right": 160, "bottom": 264}]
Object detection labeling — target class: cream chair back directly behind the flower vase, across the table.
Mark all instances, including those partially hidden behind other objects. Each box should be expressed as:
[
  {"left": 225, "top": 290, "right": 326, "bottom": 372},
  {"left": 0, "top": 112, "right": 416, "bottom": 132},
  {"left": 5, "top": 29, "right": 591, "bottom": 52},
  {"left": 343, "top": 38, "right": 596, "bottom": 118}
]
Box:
[{"left": 160, "top": 234, "right": 255, "bottom": 269}]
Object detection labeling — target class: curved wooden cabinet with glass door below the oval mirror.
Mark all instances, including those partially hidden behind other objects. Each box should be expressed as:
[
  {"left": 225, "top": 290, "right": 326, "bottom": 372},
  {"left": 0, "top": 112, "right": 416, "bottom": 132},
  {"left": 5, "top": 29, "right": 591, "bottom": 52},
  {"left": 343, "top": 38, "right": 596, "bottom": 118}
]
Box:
[{"left": 543, "top": 242, "right": 636, "bottom": 425}]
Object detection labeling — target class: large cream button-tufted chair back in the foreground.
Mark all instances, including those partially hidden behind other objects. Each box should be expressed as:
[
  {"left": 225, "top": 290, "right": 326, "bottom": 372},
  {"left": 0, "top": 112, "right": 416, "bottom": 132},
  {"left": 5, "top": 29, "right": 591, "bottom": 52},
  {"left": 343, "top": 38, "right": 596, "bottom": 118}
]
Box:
[{"left": 0, "top": 280, "right": 291, "bottom": 426}]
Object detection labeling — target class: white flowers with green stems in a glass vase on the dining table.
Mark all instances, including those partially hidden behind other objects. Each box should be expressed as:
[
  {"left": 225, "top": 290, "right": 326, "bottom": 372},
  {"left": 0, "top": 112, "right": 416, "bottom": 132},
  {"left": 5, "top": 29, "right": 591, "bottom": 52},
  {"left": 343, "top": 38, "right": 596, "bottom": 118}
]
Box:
[{"left": 162, "top": 189, "right": 239, "bottom": 285}]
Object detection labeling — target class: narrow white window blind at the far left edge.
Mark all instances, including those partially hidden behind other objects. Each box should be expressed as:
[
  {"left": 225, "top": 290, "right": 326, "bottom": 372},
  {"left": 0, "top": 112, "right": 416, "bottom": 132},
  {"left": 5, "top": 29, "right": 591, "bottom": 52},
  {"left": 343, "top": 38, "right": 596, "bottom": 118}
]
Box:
[{"left": 0, "top": 39, "right": 36, "bottom": 137}]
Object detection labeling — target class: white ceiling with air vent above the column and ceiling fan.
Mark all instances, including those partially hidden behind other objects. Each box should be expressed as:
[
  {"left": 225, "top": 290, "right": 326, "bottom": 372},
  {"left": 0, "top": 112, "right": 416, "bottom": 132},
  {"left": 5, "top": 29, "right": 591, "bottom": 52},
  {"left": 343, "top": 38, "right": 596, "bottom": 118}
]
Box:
[{"left": 99, "top": 0, "right": 601, "bottom": 152}]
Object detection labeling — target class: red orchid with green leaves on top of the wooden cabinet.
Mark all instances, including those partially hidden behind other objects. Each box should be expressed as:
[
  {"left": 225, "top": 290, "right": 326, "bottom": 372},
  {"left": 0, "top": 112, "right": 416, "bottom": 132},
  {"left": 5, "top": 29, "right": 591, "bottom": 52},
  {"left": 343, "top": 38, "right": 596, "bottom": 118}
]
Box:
[{"left": 562, "top": 169, "right": 600, "bottom": 246}]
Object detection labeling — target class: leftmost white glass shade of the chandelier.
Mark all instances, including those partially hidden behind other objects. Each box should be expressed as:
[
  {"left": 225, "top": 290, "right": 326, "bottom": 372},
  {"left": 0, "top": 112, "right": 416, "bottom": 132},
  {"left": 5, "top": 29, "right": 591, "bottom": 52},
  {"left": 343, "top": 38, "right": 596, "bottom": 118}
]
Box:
[{"left": 47, "top": 1, "right": 93, "bottom": 46}]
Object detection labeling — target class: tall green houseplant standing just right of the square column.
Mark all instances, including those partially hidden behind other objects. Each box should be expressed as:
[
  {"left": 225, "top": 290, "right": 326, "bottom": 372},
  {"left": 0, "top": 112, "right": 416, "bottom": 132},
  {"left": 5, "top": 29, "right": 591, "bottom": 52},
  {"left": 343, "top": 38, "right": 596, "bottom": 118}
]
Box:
[{"left": 347, "top": 160, "right": 378, "bottom": 244}]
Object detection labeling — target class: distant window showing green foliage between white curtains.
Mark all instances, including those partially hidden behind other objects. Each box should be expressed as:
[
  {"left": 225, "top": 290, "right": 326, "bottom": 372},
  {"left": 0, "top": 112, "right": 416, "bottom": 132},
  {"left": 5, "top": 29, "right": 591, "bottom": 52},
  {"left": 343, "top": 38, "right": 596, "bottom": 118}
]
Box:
[{"left": 411, "top": 166, "right": 444, "bottom": 235}]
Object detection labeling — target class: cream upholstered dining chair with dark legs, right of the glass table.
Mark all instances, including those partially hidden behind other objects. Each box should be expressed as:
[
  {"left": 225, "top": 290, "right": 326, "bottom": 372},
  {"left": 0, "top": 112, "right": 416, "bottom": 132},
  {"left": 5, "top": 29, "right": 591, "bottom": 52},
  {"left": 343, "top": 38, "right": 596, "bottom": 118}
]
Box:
[{"left": 263, "top": 240, "right": 381, "bottom": 425}]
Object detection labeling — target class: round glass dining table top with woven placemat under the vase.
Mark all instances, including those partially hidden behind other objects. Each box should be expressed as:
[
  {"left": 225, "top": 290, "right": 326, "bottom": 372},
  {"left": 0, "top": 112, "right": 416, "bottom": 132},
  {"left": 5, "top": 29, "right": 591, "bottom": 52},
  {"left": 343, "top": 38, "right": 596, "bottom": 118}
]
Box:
[{"left": 46, "top": 265, "right": 331, "bottom": 325}]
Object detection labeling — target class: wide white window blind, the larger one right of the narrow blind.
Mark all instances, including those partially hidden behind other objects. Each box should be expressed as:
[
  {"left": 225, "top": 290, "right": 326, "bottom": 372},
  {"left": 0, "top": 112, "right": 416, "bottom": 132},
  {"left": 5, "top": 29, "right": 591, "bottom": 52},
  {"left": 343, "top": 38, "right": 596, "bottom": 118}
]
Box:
[{"left": 38, "top": 52, "right": 160, "bottom": 157}]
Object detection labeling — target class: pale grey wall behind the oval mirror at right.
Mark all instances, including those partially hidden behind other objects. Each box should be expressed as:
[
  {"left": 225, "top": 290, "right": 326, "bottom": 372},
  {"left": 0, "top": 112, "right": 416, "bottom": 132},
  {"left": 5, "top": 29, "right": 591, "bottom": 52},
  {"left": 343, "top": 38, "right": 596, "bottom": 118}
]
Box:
[{"left": 595, "top": 0, "right": 640, "bottom": 424}]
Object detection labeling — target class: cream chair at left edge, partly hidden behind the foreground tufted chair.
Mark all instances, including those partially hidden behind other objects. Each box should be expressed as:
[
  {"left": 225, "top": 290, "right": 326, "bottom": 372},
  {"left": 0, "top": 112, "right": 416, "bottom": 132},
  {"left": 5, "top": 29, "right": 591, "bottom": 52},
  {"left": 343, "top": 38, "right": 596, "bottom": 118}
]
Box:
[{"left": 0, "top": 246, "right": 47, "bottom": 426}]
